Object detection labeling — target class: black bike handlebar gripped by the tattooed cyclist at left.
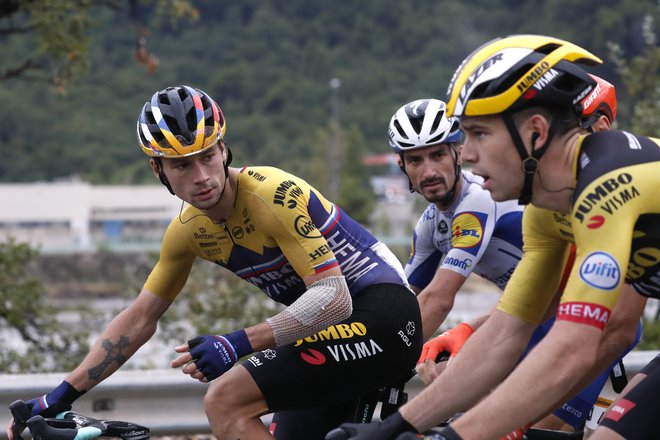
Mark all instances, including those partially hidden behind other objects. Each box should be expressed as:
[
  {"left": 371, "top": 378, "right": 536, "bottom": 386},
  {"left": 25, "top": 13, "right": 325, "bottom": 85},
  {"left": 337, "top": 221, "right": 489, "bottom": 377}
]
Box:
[{"left": 9, "top": 400, "right": 150, "bottom": 440}]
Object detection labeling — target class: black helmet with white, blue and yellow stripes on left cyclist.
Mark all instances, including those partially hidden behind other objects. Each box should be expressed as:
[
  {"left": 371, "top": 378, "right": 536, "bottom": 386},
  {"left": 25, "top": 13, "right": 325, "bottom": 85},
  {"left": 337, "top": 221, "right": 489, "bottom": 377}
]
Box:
[{"left": 137, "top": 85, "right": 227, "bottom": 157}]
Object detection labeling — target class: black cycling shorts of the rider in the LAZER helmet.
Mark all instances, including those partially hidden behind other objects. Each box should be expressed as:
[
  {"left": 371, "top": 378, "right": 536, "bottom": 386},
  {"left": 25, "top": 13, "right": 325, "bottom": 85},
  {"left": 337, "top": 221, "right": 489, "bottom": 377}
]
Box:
[{"left": 600, "top": 355, "right": 660, "bottom": 440}]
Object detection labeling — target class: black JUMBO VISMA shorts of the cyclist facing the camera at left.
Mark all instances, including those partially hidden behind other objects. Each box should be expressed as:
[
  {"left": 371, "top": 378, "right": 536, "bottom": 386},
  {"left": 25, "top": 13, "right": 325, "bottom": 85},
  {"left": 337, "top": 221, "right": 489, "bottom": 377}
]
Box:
[{"left": 242, "top": 284, "right": 423, "bottom": 440}]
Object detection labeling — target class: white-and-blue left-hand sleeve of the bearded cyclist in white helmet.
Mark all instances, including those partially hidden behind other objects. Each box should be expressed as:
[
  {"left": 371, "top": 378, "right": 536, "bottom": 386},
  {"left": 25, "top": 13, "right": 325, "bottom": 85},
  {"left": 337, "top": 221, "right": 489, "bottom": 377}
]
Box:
[{"left": 404, "top": 206, "right": 444, "bottom": 289}]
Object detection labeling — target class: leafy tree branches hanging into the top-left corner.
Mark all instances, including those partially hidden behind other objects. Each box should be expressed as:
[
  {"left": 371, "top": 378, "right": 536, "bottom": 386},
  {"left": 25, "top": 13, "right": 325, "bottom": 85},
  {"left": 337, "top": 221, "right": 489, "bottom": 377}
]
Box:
[{"left": 0, "top": 0, "right": 198, "bottom": 91}]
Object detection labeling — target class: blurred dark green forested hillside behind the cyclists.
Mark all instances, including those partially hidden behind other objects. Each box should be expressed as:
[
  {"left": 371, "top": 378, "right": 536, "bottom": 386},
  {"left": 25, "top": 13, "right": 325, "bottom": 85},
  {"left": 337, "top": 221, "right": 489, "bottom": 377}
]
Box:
[{"left": 0, "top": 0, "right": 659, "bottom": 192}]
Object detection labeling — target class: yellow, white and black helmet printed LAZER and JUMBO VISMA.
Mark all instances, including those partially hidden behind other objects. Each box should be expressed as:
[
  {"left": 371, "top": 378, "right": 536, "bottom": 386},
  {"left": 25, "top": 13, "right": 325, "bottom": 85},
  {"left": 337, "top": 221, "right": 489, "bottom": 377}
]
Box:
[{"left": 447, "top": 35, "right": 602, "bottom": 117}]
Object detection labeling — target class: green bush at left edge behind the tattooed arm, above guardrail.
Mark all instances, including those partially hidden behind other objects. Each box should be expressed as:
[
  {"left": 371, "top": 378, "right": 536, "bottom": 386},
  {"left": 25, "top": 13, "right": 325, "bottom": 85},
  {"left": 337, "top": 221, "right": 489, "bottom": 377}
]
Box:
[{"left": 0, "top": 239, "right": 88, "bottom": 373}]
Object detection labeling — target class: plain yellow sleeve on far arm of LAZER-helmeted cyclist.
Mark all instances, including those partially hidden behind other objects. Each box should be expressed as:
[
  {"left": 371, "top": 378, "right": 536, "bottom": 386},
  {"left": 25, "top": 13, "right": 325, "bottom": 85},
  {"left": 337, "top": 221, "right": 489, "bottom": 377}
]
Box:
[{"left": 497, "top": 205, "right": 570, "bottom": 325}]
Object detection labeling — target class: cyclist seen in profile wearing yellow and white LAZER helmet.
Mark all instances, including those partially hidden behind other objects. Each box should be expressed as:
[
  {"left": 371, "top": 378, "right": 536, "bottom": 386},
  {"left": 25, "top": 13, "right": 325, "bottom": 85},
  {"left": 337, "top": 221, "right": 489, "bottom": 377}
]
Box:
[{"left": 328, "top": 35, "right": 660, "bottom": 440}]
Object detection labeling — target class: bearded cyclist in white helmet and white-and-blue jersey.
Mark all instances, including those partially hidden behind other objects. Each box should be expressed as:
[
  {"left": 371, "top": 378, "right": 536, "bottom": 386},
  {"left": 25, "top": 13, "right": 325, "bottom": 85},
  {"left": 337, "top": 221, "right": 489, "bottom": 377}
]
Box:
[{"left": 389, "top": 99, "right": 523, "bottom": 339}]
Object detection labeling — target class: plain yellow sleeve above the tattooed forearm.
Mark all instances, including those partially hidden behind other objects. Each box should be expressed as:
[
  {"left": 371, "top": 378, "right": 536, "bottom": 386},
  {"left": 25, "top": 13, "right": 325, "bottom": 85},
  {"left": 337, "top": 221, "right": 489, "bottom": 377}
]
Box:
[{"left": 144, "top": 219, "right": 195, "bottom": 302}]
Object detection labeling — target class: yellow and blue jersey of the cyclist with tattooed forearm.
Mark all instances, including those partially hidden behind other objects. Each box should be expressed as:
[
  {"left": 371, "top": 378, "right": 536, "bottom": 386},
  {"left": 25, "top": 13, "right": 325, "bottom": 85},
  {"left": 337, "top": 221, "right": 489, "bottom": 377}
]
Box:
[{"left": 144, "top": 167, "right": 406, "bottom": 305}]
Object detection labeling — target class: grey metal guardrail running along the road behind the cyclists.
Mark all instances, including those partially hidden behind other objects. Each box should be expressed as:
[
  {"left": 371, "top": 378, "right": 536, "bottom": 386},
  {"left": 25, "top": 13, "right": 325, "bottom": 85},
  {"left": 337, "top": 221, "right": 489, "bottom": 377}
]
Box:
[{"left": 0, "top": 351, "right": 660, "bottom": 439}]
